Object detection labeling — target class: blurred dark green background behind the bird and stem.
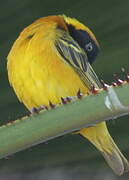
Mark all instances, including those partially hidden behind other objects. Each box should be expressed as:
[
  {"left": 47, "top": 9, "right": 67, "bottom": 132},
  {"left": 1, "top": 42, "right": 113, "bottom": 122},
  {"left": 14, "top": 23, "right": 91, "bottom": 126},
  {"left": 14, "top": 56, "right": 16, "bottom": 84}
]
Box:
[{"left": 0, "top": 0, "right": 129, "bottom": 180}]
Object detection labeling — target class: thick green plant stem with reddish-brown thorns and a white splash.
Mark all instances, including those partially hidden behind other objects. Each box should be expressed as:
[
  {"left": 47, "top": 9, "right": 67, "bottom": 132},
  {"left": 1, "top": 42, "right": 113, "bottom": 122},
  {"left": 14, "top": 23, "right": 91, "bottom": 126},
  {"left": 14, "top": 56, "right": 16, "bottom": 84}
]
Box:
[{"left": 0, "top": 83, "right": 129, "bottom": 158}]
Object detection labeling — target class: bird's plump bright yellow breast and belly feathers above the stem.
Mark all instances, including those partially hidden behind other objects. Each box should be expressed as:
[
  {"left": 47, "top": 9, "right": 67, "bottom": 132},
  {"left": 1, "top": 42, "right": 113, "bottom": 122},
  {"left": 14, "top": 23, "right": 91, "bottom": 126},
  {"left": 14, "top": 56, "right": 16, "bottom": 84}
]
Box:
[{"left": 8, "top": 22, "right": 88, "bottom": 109}]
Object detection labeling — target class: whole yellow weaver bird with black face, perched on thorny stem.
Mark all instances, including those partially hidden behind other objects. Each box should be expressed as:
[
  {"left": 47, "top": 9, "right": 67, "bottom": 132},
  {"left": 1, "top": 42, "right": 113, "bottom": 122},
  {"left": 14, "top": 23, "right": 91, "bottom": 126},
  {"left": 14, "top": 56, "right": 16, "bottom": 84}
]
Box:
[{"left": 7, "top": 15, "right": 129, "bottom": 175}]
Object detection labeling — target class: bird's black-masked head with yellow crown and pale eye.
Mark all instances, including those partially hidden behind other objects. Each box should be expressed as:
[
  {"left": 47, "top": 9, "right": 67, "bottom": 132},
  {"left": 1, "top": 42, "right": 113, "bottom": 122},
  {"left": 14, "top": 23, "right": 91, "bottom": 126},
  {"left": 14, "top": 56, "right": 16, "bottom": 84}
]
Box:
[{"left": 62, "top": 15, "right": 100, "bottom": 63}]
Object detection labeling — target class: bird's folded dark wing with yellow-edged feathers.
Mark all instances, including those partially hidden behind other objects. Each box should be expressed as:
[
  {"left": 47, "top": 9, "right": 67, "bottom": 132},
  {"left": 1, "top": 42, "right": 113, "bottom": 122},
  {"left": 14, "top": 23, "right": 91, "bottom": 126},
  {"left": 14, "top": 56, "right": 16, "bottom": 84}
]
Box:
[{"left": 55, "top": 32, "right": 102, "bottom": 90}]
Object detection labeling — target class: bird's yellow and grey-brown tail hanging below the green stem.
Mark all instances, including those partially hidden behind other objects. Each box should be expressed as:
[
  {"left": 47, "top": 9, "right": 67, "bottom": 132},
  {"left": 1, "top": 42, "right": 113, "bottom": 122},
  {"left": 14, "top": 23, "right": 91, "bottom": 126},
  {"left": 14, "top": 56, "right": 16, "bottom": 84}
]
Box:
[{"left": 79, "top": 122, "right": 129, "bottom": 175}]
